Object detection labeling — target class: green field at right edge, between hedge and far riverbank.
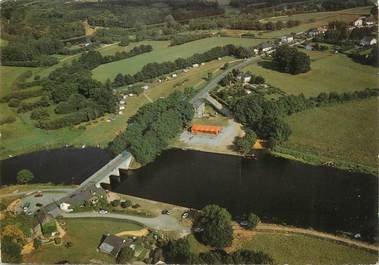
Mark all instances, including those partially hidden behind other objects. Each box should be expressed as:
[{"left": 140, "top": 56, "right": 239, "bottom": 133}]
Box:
[{"left": 280, "top": 98, "right": 379, "bottom": 171}]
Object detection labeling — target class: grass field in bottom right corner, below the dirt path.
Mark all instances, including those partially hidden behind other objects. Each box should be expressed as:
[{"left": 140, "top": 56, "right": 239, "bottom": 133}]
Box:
[{"left": 243, "top": 230, "right": 377, "bottom": 265}]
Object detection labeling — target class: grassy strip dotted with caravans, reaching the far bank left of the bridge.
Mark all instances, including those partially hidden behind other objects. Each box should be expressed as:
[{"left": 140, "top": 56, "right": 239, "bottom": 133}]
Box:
[{"left": 0, "top": 57, "right": 234, "bottom": 158}]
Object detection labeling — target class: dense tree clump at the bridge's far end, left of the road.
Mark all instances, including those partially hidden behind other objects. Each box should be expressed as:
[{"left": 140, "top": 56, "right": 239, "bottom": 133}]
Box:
[{"left": 108, "top": 91, "right": 193, "bottom": 164}]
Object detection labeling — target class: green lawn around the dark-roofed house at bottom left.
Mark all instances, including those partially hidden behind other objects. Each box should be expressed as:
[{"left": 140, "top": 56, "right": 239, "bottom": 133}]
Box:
[{"left": 24, "top": 219, "right": 142, "bottom": 264}]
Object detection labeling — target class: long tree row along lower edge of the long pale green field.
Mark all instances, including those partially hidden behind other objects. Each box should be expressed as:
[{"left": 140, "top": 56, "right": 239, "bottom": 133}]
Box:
[{"left": 113, "top": 44, "right": 254, "bottom": 87}]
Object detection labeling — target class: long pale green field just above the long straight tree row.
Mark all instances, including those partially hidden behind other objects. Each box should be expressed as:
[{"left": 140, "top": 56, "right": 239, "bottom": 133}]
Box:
[{"left": 93, "top": 37, "right": 270, "bottom": 81}]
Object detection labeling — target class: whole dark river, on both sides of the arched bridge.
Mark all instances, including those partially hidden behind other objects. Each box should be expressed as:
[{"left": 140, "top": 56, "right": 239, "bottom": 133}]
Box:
[{"left": 1, "top": 148, "right": 378, "bottom": 241}]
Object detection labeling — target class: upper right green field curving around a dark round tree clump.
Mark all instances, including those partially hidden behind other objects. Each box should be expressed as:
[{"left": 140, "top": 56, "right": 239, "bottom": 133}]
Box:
[{"left": 244, "top": 50, "right": 378, "bottom": 96}]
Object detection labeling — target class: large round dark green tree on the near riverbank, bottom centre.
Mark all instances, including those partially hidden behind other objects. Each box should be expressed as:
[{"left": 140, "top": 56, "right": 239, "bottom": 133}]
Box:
[{"left": 194, "top": 205, "right": 233, "bottom": 248}]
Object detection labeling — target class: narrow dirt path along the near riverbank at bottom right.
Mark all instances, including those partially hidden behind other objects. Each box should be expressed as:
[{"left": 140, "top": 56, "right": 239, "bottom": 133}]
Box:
[{"left": 256, "top": 223, "right": 379, "bottom": 251}]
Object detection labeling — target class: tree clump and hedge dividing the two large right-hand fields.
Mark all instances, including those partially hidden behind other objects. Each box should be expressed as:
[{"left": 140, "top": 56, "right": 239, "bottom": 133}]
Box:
[{"left": 231, "top": 88, "right": 379, "bottom": 145}]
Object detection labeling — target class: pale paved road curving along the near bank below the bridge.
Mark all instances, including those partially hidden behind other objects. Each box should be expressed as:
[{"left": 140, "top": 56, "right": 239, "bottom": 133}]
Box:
[{"left": 62, "top": 212, "right": 191, "bottom": 235}]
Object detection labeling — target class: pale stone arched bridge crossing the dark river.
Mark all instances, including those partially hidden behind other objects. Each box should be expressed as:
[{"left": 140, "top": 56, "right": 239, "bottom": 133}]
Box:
[{"left": 80, "top": 151, "right": 133, "bottom": 187}]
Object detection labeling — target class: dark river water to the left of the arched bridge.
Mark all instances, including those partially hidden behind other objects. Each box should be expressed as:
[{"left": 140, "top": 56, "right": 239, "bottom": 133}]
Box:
[{"left": 0, "top": 147, "right": 111, "bottom": 185}]
